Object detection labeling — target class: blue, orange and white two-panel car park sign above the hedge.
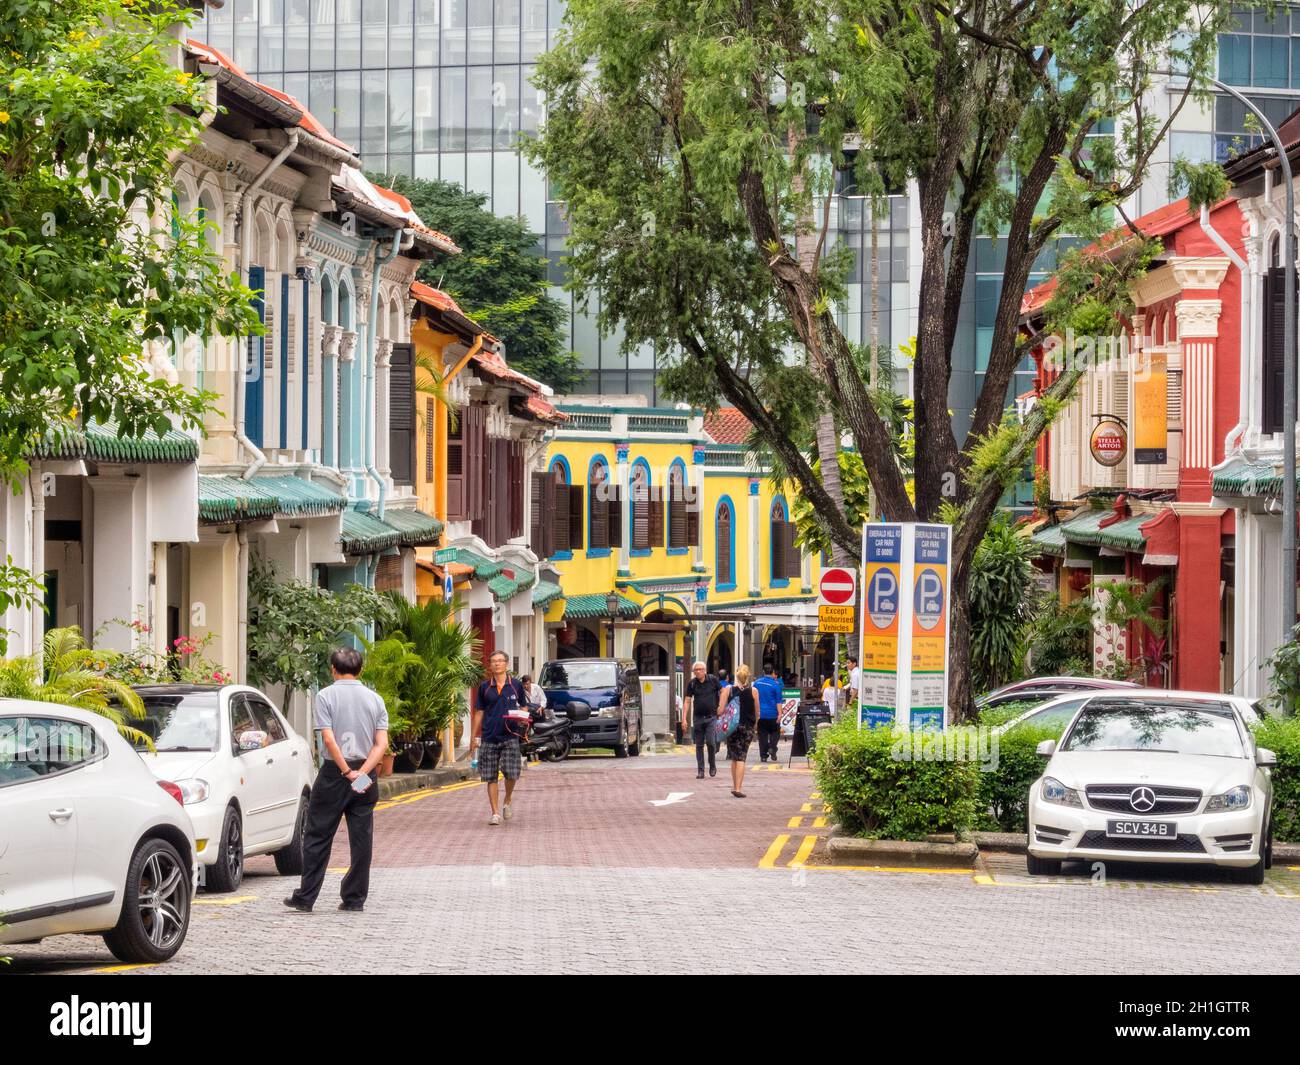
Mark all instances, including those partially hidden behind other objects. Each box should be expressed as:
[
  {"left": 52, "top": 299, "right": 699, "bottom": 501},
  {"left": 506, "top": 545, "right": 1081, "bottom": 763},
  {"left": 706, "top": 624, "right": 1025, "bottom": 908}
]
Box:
[{"left": 858, "top": 523, "right": 952, "bottom": 730}]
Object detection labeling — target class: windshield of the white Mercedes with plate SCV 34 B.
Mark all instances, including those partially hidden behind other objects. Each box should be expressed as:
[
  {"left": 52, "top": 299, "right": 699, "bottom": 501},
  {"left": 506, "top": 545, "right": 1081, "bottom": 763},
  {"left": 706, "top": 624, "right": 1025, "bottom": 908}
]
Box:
[{"left": 1061, "top": 702, "right": 1245, "bottom": 758}]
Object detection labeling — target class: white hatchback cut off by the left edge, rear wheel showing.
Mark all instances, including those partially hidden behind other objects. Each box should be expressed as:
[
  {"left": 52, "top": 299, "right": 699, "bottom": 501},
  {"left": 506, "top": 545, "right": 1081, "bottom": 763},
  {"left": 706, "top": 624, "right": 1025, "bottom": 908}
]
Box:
[{"left": 0, "top": 698, "right": 195, "bottom": 962}]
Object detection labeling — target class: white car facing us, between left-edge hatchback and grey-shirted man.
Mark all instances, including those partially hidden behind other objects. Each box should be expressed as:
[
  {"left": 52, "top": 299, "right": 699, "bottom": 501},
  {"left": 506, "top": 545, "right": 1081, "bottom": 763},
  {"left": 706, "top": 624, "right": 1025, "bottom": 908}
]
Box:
[{"left": 134, "top": 684, "right": 315, "bottom": 892}]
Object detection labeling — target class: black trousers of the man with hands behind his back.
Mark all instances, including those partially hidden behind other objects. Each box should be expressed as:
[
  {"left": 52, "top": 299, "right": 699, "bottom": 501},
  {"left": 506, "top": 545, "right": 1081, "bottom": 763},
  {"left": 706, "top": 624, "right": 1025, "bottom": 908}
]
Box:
[{"left": 294, "top": 759, "right": 380, "bottom": 905}]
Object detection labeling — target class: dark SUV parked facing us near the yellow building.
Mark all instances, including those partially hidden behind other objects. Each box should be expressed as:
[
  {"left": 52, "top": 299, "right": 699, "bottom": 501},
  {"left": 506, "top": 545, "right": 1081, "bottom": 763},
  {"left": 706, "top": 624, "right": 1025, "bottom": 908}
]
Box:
[{"left": 541, "top": 658, "right": 641, "bottom": 758}]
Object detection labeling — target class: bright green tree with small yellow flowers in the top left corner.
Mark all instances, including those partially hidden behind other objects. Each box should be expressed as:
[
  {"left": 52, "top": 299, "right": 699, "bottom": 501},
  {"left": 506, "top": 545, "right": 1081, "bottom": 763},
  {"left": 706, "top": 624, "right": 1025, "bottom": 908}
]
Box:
[{"left": 0, "top": 0, "right": 256, "bottom": 616}]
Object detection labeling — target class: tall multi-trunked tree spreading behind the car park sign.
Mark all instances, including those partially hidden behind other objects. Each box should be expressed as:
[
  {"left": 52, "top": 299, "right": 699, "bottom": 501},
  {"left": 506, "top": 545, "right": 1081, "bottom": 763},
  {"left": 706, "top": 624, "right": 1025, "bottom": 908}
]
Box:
[{"left": 524, "top": 0, "right": 1230, "bottom": 715}]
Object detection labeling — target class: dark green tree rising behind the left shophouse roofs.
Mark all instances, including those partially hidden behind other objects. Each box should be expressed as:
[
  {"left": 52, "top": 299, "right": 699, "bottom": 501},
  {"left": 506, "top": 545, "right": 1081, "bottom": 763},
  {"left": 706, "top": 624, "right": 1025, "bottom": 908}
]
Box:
[{"left": 376, "top": 176, "right": 582, "bottom": 393}]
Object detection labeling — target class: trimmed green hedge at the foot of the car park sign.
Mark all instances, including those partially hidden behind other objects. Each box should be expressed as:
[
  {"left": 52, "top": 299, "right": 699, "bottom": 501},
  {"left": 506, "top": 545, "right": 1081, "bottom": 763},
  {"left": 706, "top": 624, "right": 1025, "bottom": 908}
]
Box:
[{"left": 814, "top": 719, "right": 980, "bottom": 840}]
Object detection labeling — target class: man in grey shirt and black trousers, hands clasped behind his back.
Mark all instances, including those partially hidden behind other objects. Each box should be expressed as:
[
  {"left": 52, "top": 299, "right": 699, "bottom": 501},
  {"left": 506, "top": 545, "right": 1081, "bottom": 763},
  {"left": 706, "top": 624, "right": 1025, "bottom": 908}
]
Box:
[{"left": 285, "top": 648, "right": 389, "bottom": 913}]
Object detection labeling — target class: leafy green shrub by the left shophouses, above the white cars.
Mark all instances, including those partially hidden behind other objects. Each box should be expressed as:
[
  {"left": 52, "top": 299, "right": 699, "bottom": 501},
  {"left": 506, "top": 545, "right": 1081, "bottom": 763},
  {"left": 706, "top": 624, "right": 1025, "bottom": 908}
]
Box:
[{"left": 248, "top": 557, "right": 389, "bottom": 706}]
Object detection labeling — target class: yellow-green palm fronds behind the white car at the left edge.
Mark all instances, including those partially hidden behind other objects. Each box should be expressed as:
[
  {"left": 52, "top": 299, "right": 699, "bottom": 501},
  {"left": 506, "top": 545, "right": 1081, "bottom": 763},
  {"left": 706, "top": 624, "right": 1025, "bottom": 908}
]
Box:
[{"left": 0, "top": 625, "right": 153, "bottom": 749}]
